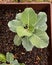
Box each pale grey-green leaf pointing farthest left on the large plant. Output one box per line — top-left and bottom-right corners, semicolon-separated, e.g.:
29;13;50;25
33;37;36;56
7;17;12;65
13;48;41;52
8;20;22;32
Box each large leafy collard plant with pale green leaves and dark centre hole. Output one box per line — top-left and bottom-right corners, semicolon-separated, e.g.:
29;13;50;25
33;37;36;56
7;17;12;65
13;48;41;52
8;8;49;51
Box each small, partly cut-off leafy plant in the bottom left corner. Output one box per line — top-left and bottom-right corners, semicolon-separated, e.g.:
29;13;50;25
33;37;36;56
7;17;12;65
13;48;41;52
0;52;25;65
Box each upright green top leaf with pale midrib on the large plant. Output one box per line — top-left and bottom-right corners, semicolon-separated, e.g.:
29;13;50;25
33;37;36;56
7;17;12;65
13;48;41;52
21;8;37;28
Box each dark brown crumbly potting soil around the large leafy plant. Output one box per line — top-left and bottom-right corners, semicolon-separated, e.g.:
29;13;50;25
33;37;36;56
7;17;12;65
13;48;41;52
0;9;49;65
